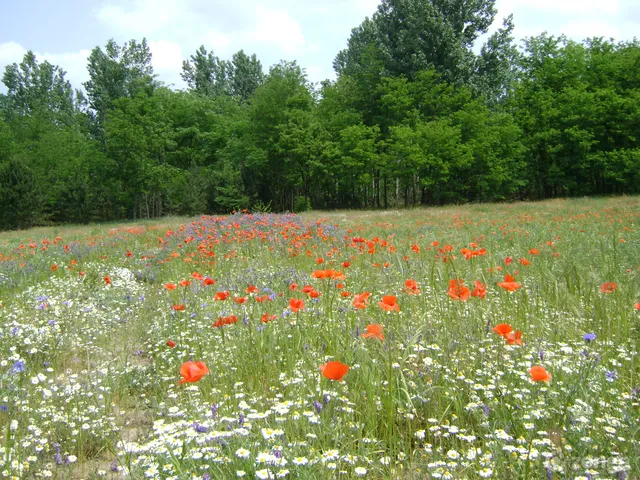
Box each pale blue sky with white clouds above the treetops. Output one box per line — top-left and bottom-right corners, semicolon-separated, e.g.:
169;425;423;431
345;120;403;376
0;0;640;91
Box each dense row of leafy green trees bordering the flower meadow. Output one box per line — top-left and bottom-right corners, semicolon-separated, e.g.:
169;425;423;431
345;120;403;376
0;0;640;229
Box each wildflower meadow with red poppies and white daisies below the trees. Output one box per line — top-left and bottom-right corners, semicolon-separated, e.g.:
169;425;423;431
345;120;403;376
0;197;640;480
